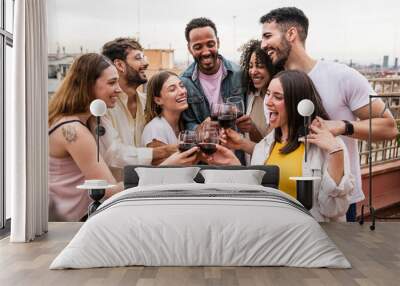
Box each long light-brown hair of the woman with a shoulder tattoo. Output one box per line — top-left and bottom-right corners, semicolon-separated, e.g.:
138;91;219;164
48;53;112;126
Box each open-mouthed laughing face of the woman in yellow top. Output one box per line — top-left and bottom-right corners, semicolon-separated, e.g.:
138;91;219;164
266;78;288;128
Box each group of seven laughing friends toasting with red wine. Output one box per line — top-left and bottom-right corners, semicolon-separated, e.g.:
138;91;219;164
48;7;398;221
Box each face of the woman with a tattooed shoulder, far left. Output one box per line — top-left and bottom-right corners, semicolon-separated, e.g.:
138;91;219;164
93;66;121;108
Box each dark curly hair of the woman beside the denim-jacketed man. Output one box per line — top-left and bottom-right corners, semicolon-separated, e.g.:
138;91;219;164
240;40;280;92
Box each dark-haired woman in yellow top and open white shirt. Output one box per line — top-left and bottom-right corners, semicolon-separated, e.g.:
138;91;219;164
203;71;354;221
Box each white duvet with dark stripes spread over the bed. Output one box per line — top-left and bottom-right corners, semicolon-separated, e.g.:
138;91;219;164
50;184;351;269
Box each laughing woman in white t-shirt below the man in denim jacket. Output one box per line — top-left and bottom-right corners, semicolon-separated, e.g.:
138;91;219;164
142;71;198;165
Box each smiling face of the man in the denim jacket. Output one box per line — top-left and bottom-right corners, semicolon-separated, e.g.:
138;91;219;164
188;26;219;74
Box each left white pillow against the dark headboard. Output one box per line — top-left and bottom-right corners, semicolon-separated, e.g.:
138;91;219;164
135;167;200;186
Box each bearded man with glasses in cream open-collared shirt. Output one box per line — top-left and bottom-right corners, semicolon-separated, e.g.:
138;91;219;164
100;38;177;180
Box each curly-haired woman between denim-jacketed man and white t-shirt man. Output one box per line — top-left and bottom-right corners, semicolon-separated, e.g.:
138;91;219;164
236;40;277;143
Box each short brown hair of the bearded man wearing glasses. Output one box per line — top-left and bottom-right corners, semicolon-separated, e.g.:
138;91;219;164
101;38;143;61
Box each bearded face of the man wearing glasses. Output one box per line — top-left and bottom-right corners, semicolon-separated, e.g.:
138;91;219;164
123;50;149;85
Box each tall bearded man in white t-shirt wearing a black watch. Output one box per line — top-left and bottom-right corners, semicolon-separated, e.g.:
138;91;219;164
260;7;398;221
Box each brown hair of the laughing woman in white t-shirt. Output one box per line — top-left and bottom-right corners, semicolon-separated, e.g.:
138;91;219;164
144;71;178;123
